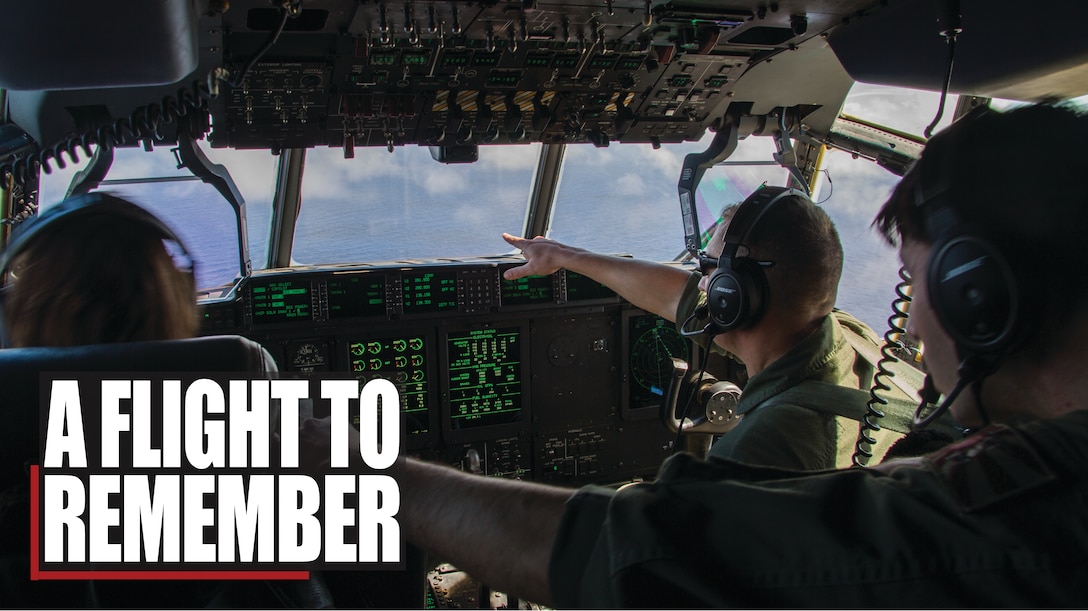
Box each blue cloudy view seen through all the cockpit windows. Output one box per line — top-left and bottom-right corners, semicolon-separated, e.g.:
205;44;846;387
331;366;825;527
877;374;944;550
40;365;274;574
41;85;979;332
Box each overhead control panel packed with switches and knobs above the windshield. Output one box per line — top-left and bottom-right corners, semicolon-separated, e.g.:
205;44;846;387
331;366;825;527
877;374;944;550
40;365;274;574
211;0;865;151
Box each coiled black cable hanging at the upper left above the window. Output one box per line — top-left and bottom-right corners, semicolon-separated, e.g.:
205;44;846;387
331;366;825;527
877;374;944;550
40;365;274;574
0;80;211;186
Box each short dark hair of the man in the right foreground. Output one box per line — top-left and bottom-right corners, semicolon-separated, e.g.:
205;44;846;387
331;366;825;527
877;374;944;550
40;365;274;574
873;104;1088;345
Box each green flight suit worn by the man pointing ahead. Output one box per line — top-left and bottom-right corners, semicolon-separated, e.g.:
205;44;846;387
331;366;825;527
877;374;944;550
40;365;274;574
676;273;878;471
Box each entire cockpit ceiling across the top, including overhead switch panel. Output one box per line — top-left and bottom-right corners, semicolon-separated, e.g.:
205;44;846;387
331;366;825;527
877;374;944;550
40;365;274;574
0;0;1088;156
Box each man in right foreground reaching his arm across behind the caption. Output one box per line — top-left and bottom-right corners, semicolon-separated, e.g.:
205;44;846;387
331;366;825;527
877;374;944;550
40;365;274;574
302;101;1088;608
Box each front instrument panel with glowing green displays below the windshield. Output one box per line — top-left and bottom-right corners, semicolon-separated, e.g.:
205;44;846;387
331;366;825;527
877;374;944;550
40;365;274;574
201;262;690;485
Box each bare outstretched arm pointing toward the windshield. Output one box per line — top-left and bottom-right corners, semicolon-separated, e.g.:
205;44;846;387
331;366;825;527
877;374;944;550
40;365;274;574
503;234;691;321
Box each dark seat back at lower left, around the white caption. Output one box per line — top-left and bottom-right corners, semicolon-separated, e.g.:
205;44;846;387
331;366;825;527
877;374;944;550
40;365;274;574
0;335;306;609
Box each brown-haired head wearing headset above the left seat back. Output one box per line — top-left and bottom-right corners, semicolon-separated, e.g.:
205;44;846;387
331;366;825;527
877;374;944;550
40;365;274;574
0;194;197;347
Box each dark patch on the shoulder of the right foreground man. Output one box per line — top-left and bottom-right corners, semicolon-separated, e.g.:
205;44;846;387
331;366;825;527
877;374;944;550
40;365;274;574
928;426;1056;512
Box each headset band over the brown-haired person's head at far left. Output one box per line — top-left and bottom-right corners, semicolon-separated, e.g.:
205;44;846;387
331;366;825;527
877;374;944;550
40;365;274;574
0;194;196;347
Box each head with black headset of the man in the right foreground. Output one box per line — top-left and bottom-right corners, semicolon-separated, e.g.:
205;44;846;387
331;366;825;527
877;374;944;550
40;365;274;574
874;105;1088;426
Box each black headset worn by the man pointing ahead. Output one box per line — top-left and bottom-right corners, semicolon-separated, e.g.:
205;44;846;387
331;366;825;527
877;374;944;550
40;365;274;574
698;187;812;333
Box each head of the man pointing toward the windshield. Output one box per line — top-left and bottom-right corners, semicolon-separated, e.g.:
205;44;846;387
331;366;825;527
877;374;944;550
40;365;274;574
700;187;842;331
